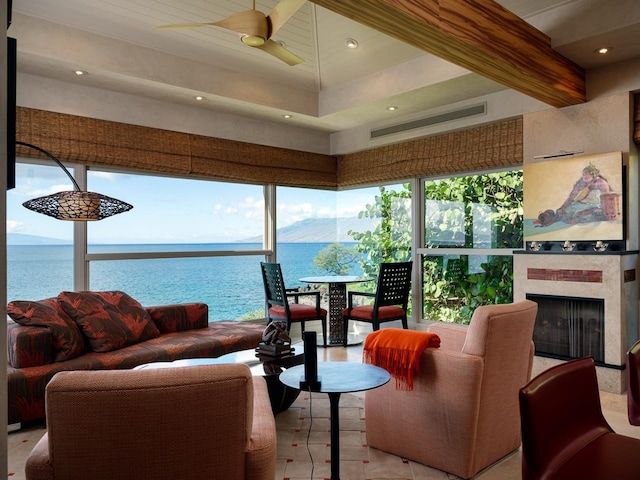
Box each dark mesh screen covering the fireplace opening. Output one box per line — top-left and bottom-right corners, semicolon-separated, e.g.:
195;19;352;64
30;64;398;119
527;295;604;362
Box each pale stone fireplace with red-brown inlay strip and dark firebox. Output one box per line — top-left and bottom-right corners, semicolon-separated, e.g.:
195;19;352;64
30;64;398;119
513;250;639;394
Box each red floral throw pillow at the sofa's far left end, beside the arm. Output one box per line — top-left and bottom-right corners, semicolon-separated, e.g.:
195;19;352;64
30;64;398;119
7;298;85;362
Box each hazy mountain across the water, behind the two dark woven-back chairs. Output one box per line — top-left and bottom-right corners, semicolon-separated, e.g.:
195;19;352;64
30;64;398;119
241;217;374;243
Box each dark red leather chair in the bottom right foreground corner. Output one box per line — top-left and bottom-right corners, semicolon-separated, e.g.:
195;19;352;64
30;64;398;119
520;357;640;480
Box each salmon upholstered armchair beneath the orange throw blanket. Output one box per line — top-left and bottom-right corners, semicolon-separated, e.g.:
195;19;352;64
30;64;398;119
365;300;538;478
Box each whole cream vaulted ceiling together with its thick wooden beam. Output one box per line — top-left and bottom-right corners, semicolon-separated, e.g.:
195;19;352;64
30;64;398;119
9;0;640;132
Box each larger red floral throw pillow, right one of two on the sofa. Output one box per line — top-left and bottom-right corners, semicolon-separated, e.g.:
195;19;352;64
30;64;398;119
58;291;160;352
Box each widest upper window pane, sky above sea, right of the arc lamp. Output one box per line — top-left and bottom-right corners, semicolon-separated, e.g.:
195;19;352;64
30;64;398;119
87;170;264;249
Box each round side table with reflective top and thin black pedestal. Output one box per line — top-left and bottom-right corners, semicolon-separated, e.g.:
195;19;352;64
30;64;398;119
280;362;391;480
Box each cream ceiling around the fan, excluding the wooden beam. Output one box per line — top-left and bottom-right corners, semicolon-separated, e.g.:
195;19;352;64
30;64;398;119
9;0;640;132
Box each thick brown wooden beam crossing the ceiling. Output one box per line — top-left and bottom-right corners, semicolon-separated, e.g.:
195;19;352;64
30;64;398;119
311;0;586;108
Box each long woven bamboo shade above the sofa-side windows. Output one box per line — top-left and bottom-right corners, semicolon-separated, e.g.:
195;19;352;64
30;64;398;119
16;107;336;189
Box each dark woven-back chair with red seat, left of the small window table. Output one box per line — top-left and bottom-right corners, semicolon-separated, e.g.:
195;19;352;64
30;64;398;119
260;262;327;346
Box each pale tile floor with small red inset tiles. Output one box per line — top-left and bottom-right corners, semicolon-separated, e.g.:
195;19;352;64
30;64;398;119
8;346;640;480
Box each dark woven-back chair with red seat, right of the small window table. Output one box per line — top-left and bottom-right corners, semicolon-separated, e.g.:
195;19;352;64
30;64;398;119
342;262;412;346
